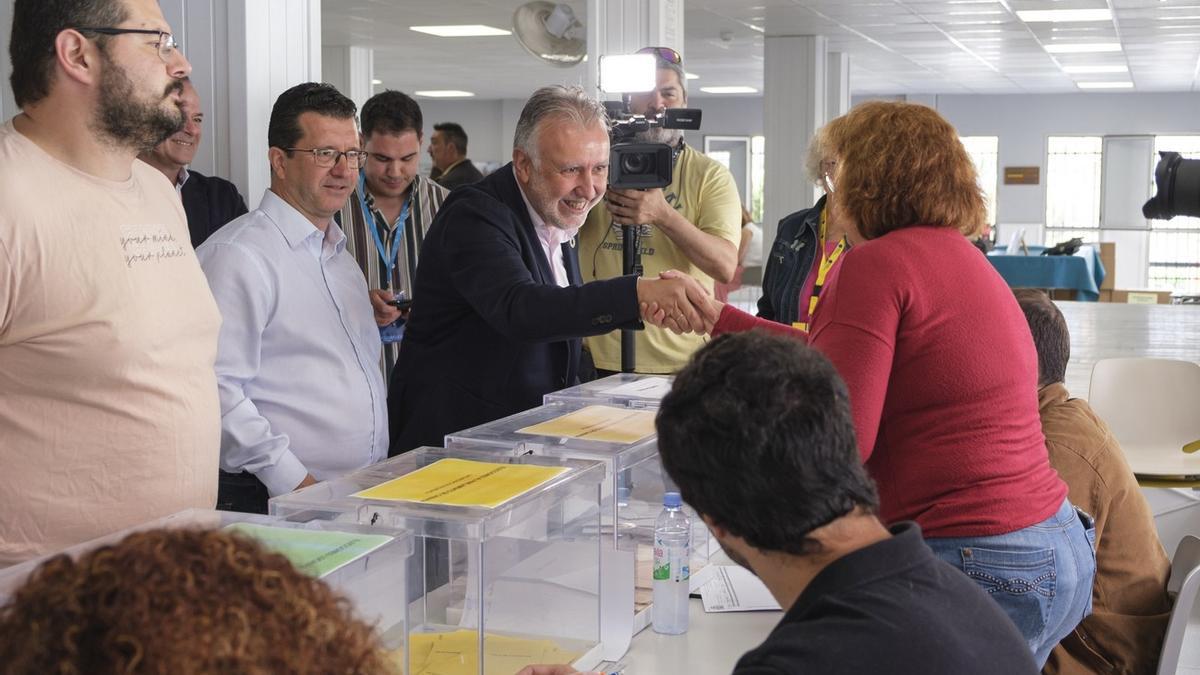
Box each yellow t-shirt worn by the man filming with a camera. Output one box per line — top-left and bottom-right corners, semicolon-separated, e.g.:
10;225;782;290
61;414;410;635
578;145;742;372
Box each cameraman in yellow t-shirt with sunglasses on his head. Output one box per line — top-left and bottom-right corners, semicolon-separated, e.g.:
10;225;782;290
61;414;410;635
580;47;742;376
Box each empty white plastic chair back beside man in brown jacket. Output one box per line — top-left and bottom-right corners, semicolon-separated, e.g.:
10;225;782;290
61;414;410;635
1087;358;1200;484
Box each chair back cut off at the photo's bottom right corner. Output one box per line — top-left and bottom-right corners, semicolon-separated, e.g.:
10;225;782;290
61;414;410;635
1158;534;1200;675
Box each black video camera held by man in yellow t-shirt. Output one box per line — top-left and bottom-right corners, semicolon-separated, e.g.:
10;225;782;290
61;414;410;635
605;101;701;190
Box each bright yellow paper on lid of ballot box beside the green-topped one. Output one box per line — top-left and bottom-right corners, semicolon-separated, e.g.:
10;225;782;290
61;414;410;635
354;459;566;508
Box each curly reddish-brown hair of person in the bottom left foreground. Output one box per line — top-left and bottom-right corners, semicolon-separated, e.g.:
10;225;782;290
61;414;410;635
0;530;396;675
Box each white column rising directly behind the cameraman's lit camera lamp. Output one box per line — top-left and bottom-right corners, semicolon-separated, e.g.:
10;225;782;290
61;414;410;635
582;0;688;98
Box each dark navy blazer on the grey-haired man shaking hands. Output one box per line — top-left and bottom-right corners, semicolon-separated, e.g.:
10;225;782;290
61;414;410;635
388;163;638;455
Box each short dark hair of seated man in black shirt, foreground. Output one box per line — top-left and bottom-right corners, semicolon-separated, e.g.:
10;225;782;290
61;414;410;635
655;330;878;555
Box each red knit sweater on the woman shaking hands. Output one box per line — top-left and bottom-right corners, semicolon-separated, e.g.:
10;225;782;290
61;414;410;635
713;227;1067;537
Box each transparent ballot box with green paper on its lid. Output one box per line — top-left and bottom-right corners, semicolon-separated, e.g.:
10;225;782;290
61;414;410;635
0;509;413;652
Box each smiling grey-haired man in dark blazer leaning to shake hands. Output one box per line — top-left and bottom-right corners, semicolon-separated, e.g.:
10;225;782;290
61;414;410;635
388;86;702;455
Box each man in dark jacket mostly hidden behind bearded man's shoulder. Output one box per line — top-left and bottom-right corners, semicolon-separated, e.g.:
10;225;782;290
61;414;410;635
138;78;247;249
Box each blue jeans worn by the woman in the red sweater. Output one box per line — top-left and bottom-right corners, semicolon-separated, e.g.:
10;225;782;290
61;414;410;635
925;500;1096;667
